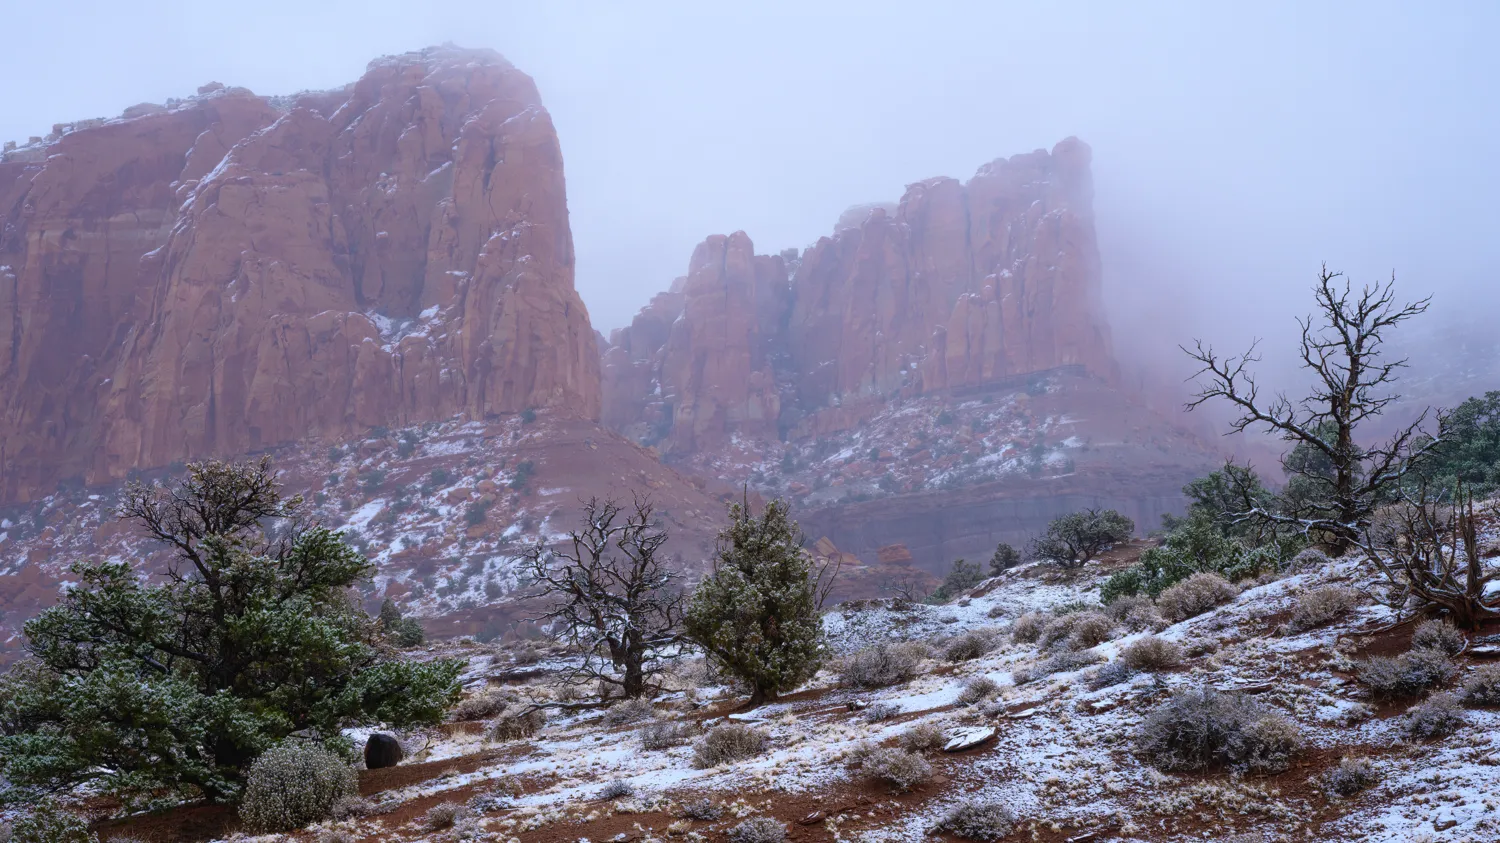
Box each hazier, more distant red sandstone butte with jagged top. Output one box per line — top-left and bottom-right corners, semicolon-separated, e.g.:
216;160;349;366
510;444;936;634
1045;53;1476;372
603;138;1119;456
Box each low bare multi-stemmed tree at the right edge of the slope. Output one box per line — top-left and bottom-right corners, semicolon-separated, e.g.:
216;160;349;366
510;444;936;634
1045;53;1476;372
1361;482;1500;629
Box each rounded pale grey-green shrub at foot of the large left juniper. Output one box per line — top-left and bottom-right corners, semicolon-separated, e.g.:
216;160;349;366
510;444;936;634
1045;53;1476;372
240;744;359;831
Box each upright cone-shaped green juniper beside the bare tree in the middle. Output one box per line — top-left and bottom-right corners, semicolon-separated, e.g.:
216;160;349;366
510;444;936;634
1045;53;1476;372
686;501;839;707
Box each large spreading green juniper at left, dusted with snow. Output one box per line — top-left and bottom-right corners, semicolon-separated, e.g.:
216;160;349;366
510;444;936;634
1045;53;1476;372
0;459;462;801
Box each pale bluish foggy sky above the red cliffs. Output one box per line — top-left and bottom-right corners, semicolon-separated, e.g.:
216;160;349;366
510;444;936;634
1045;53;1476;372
0;0;1500;405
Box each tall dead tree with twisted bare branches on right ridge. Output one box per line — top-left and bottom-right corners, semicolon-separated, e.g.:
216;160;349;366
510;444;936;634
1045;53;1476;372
1184;266;1443;554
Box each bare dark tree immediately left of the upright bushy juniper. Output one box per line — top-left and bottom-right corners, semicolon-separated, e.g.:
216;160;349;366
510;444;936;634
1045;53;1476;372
524;495;684;698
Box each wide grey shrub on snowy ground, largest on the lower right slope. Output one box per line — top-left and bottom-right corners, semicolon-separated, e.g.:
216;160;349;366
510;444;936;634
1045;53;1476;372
1136;687;1302;773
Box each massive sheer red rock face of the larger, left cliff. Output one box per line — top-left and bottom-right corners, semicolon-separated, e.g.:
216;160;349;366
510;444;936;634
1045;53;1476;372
0;48;600;500
